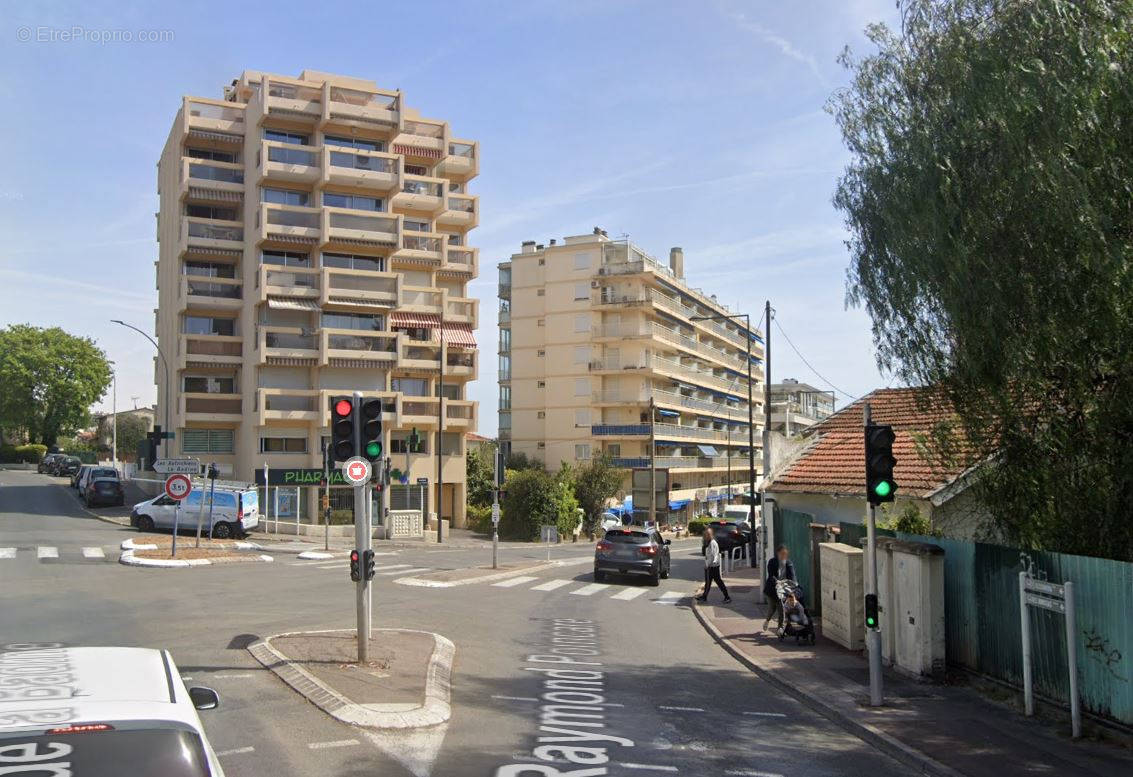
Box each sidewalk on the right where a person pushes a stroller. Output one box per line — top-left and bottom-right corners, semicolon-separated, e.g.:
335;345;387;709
693;567;1133;777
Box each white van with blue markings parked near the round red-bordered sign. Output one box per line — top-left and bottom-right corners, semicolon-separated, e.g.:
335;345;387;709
130;486;259;539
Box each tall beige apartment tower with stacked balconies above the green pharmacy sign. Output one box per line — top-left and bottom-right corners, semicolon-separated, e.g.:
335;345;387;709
155;70;478;526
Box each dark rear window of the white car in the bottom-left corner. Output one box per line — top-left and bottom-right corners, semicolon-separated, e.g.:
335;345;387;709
0;728;212;777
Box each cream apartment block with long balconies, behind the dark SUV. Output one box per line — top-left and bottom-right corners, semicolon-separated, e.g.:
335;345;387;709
499;229;764;520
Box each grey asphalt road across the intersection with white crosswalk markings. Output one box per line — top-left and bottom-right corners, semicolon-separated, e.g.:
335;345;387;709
0;471;908;777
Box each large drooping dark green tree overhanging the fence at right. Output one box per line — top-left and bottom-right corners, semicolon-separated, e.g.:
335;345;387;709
829;0;1133;560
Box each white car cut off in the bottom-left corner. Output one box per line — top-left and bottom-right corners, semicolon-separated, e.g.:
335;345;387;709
0;648;224;777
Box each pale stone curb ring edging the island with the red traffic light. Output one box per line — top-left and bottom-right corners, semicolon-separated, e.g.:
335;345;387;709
248;629;457;729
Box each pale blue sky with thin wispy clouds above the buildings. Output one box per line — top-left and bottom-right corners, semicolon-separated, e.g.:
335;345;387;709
0;0;896;436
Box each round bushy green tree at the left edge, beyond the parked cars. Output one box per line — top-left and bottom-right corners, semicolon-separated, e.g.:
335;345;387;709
0;324;110;446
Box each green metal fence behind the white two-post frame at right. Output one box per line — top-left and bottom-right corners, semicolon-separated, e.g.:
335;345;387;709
838;523;1133;725
